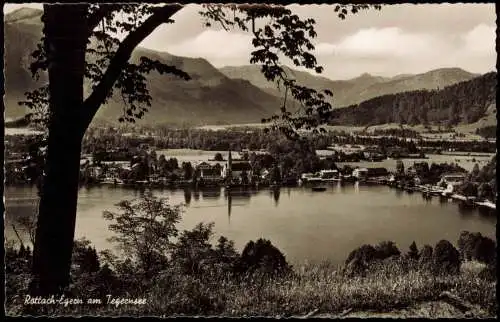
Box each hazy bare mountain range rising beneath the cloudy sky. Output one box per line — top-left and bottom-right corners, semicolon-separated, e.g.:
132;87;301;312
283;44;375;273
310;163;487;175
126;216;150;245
4;8;494;125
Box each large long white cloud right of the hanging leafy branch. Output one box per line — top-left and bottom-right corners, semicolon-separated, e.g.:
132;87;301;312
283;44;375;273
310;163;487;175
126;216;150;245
315;23;496;79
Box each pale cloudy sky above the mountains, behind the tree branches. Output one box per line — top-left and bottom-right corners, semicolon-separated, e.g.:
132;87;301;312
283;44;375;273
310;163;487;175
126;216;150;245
4;3;497;79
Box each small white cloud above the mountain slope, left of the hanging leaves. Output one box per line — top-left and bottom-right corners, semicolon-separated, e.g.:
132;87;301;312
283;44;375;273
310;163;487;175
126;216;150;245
166;30;253;66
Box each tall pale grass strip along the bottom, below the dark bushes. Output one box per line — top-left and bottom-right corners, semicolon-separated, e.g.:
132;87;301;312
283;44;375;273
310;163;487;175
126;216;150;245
7;244;496;316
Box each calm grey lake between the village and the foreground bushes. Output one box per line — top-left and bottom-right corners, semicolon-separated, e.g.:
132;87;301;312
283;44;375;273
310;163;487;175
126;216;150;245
5;184;496;264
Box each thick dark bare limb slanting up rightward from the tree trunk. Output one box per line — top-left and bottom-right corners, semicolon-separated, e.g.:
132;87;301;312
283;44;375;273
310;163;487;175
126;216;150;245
82;4;183;128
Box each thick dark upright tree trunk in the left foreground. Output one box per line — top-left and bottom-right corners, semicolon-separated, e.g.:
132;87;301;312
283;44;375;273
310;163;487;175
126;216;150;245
32;4;87;295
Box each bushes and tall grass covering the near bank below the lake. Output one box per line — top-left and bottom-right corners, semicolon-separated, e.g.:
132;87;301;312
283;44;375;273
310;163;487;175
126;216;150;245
6;196;496;316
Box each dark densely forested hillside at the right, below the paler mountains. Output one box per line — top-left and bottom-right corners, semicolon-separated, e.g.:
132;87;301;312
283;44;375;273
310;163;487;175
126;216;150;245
330;72;497;126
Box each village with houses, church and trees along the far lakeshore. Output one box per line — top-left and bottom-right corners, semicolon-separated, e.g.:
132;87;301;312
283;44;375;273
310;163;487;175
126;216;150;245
6;126;496;214
